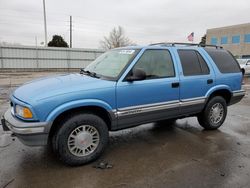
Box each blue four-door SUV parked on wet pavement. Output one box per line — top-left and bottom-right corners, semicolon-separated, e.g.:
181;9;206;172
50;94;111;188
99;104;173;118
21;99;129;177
1;43;245;165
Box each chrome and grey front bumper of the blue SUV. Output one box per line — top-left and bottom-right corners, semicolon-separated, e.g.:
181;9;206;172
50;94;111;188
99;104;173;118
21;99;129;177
1;109;51;146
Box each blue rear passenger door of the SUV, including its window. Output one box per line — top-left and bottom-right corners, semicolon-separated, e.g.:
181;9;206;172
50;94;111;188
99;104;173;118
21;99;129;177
177;49;215;115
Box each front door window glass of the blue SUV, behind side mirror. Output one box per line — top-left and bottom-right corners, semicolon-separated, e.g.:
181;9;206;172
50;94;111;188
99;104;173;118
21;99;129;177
133;50;175;79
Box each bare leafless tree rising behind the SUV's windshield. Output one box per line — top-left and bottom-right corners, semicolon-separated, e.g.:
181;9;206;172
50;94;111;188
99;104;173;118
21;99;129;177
100;26;134;50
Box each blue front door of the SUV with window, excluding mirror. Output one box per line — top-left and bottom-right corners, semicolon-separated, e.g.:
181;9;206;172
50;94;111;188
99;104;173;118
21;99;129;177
116;49;179;128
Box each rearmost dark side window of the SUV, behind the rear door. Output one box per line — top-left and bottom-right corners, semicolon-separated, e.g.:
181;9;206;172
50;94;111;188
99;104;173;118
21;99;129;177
204;48;241;73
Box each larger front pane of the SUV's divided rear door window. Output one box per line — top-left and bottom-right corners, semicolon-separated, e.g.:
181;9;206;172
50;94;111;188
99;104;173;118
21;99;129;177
178;50;202;76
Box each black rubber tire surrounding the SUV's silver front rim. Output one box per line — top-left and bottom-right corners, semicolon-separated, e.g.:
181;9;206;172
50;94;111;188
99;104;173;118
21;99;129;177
52;113;109;166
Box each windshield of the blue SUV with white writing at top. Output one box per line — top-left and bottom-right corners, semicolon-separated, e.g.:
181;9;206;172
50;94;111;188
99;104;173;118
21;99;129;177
84;49;139;79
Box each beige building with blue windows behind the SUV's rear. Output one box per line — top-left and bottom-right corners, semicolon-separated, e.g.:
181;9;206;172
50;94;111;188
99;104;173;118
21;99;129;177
206;23;250;58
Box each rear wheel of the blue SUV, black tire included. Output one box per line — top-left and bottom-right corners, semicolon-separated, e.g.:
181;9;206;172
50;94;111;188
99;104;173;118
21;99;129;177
197;96;227;130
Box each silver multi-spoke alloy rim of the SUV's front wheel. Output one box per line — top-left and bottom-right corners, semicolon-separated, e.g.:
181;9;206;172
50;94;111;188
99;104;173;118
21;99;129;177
68;125;100;157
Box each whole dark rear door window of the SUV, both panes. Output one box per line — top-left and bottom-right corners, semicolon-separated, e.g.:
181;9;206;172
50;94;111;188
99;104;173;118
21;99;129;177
178;50;209;76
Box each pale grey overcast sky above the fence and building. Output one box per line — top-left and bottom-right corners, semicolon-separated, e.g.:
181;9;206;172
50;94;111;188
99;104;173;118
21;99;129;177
0;0;250;48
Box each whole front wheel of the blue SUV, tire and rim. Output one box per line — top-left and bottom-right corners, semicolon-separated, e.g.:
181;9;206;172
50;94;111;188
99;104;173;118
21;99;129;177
52;114;109;165
